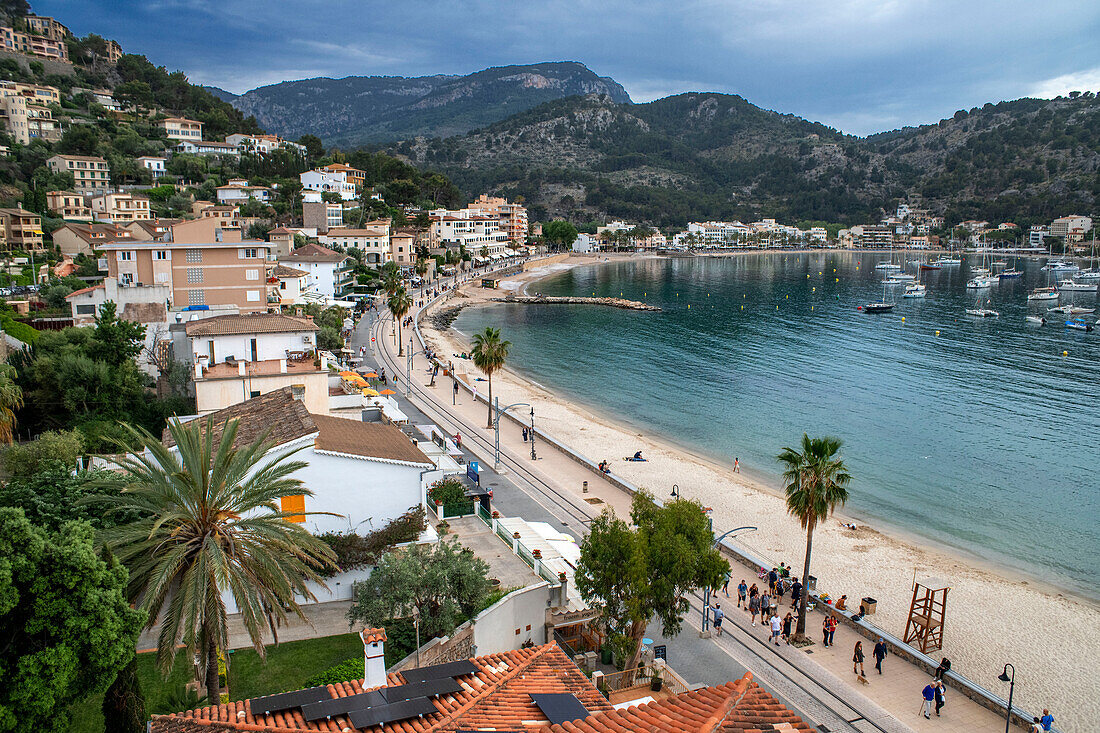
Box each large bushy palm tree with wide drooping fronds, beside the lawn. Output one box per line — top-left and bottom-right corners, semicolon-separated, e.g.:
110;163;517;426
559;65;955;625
94;417;336;700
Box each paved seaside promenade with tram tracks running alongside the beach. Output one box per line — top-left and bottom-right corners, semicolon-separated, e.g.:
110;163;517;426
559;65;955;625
352;277;1004;733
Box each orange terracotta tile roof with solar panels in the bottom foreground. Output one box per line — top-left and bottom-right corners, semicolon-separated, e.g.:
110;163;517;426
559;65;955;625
151;644;813;733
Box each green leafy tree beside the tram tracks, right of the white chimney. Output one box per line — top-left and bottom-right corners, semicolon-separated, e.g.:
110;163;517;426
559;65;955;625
576;491;729;668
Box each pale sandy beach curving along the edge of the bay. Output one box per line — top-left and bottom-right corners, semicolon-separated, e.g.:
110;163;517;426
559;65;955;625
421;256;1100;733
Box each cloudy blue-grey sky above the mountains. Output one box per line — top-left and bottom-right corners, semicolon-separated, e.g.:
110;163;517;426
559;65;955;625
31;0;1100;135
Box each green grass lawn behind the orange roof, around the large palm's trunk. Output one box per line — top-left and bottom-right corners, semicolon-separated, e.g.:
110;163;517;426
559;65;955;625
69;634;363;733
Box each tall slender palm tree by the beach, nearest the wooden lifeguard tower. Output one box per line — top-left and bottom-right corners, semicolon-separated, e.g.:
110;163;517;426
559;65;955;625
778;433;851;637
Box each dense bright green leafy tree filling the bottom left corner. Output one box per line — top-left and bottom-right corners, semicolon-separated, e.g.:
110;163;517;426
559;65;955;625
0;507;145;733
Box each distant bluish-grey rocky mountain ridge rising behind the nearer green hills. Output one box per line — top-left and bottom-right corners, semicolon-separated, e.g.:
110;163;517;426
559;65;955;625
208;62;630;147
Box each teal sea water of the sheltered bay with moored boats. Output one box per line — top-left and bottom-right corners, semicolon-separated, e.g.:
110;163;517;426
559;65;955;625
454;252;1100;597
